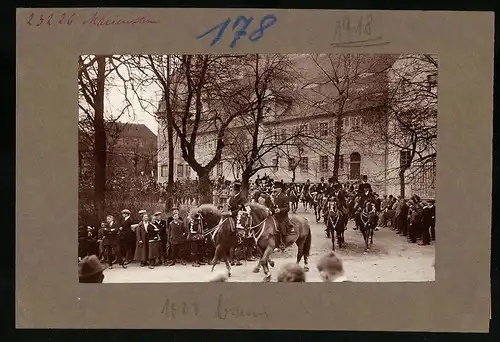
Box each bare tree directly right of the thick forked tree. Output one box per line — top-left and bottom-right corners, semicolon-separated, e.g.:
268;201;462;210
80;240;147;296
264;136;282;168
221;54;302;194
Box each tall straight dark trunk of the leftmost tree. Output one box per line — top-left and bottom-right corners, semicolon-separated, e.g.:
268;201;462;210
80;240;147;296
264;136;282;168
94;56;106;220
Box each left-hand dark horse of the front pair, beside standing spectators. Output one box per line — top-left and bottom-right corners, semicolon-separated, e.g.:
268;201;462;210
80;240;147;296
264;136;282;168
188;204;242;276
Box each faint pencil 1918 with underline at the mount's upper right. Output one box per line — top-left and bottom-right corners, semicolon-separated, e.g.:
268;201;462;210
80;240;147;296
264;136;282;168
330;14;389;48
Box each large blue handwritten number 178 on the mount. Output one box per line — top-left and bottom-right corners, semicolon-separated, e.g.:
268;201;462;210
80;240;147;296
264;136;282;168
196;14;277;48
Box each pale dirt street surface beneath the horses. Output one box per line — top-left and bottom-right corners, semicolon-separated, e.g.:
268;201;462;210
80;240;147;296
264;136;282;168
104;209;435;283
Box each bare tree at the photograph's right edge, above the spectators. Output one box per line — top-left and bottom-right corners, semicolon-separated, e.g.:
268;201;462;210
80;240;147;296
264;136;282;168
370;54;438;197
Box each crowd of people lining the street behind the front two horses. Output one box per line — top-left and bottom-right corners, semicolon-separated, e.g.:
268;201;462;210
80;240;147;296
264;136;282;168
78;171;435;278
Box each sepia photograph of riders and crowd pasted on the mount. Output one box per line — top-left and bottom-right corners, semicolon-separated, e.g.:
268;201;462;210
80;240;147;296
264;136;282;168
75;53;438;283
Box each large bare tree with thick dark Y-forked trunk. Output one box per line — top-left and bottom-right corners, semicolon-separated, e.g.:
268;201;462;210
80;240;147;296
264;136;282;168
141;55;250;203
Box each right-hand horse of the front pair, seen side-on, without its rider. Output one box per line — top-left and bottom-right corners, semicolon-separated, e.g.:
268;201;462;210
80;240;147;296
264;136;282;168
239;203;311;282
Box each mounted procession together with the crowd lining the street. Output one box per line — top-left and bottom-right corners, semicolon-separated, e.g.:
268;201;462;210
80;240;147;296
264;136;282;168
79;176;435;282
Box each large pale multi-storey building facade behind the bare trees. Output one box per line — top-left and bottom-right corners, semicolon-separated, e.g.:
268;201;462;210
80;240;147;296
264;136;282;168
158;55;438;195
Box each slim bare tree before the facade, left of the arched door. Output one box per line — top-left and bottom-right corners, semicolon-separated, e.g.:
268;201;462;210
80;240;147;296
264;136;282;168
294;54;392;177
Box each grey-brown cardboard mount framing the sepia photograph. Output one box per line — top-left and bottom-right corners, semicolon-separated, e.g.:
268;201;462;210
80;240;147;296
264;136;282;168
16;8;494;332
